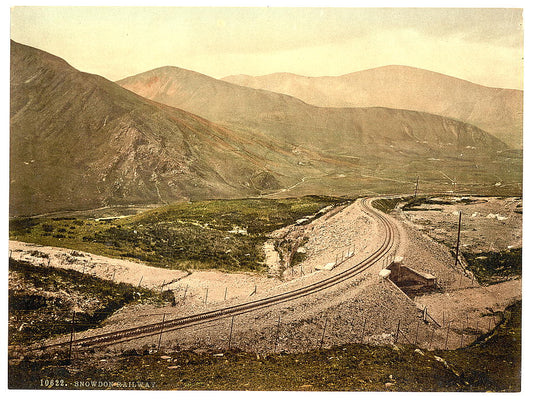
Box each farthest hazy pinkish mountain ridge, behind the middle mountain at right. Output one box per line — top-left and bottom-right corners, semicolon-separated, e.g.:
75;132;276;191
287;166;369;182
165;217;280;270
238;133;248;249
223;66;523;148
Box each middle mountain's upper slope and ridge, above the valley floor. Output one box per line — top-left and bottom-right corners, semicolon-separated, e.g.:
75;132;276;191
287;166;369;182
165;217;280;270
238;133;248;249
118;67;507;157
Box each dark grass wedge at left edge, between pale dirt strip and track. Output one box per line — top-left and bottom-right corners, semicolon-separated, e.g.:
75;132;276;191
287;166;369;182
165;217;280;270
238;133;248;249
8;259;174;345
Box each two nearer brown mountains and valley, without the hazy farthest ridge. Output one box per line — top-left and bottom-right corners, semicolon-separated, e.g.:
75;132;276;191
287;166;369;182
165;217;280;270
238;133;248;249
10;42;521;216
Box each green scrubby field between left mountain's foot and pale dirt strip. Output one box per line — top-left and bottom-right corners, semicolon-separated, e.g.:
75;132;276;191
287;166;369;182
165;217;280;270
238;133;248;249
10;196;345;272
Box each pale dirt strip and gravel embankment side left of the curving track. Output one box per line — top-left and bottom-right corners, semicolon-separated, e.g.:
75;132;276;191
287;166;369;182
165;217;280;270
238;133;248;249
9;203;378;309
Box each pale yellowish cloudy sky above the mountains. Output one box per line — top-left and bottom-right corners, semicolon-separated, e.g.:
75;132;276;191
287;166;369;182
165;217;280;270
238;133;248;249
11;7;523;89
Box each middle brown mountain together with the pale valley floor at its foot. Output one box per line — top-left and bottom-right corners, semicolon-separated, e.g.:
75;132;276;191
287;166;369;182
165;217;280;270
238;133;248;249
118;67;521;195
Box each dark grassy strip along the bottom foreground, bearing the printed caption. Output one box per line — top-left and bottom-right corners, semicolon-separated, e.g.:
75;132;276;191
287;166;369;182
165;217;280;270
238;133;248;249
9;303;522;392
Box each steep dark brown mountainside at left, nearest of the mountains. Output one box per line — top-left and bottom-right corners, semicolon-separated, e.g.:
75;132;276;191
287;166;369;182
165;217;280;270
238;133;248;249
10;42;296;215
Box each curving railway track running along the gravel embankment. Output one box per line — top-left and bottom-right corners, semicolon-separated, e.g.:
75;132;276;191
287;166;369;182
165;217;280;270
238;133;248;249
38;199;397;349
